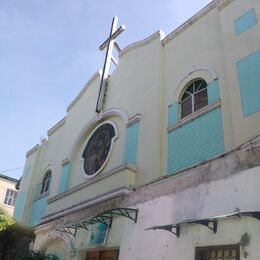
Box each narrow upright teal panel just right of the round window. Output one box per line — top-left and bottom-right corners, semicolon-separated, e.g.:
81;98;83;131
124;122;139;164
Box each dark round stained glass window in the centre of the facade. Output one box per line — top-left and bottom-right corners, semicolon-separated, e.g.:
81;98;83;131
82;123;116;177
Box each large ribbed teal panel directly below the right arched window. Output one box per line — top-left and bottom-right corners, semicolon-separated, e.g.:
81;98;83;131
167;108;224;174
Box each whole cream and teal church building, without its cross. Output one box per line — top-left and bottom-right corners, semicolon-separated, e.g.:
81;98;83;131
15;0;260;260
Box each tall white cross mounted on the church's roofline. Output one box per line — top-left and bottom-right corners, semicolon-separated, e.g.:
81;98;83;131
96;16;125;113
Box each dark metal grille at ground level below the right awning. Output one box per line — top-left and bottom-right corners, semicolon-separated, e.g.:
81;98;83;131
196;245;240;260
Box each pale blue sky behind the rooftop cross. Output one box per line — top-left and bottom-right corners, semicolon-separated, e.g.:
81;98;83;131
0;0;210;178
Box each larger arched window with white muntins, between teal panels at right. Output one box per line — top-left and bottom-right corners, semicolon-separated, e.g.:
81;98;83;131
181;79;208;118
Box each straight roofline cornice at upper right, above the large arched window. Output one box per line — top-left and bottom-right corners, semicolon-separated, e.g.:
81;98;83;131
162;0;234;46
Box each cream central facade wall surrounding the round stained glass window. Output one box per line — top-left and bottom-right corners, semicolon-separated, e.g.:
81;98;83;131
20;34;165;217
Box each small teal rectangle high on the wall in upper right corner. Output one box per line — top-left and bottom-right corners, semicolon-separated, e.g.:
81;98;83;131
235;8;257;36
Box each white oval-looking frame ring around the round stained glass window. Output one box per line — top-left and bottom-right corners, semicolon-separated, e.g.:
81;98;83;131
81;120;118;179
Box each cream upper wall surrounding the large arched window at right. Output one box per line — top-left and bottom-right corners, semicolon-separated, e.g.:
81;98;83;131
163;0;260;155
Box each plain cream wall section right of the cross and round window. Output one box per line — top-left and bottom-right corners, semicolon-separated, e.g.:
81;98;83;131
105;35;162;187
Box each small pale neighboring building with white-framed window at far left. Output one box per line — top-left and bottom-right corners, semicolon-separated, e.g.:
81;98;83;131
0;174;18;216
